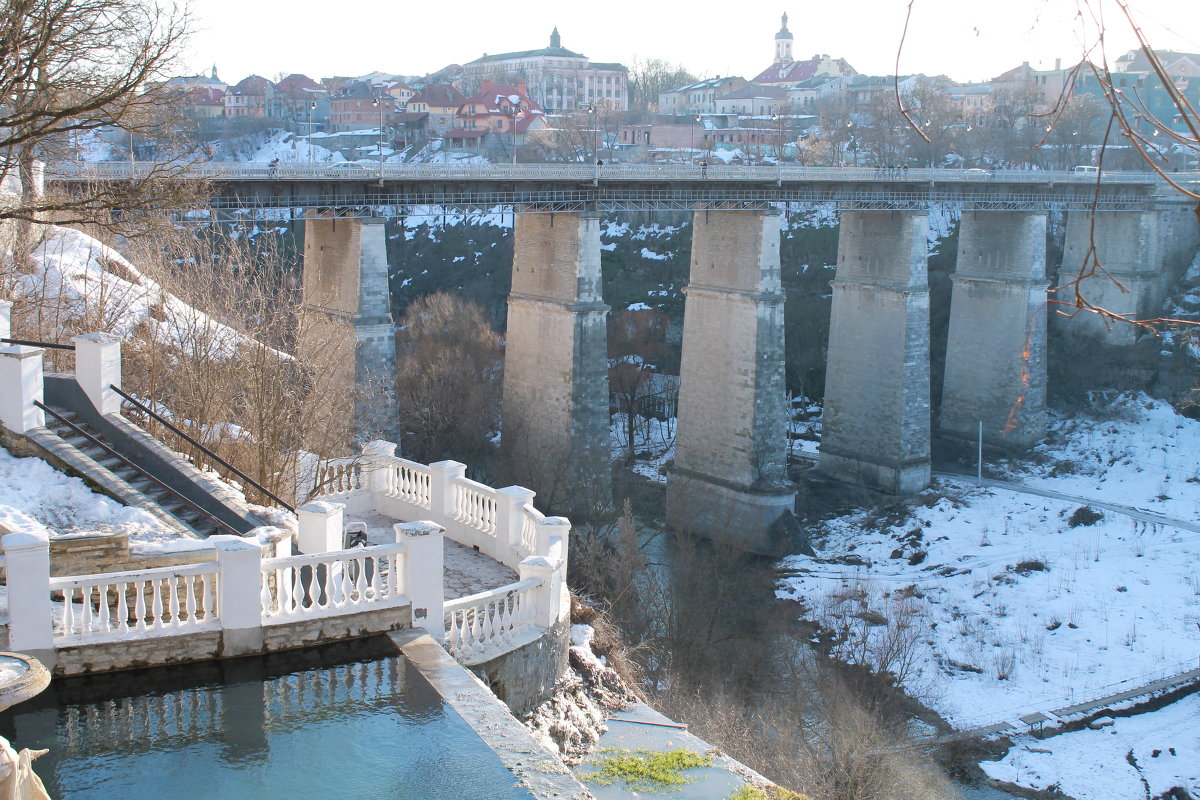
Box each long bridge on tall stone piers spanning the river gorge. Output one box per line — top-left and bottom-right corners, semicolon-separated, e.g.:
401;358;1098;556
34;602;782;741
47;163;1200;553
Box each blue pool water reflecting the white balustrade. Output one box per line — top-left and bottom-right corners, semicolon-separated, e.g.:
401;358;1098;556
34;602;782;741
0;651;529;800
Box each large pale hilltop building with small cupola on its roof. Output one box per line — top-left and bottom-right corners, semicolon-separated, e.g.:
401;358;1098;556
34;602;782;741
462;28;629;112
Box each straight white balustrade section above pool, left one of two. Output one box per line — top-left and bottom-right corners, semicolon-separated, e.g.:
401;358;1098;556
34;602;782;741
50;561;218;646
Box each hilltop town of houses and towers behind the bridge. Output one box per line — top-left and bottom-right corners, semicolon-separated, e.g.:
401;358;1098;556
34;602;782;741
145;13;1200;169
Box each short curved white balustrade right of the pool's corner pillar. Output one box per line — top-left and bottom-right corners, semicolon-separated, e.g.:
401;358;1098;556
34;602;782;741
444;578;542;657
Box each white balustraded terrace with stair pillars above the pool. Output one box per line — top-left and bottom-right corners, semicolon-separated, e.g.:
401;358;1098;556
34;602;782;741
0;316;570;708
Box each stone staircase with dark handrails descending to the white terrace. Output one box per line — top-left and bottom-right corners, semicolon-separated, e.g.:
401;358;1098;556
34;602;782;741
31;408;244;539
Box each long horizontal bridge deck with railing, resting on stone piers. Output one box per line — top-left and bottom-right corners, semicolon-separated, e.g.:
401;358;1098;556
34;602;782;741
47;162;1200;216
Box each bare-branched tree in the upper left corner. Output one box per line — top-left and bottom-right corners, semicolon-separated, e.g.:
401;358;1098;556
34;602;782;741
0;0;204;246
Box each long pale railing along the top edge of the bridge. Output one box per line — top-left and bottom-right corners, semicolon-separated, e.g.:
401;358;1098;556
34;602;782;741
47;161;1198;185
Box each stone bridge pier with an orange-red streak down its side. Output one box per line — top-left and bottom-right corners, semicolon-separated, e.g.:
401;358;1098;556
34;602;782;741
938;211;1048;449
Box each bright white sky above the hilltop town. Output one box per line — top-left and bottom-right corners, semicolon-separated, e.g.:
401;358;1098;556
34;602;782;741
184;0;1200;83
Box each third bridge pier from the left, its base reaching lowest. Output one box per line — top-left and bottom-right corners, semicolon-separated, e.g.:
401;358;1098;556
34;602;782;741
667;211;796;554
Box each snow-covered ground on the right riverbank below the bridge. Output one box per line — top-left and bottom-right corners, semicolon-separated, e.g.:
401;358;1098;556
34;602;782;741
779;395;1200;800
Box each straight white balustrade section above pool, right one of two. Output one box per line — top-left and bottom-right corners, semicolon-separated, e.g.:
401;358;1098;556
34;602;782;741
259;543;408;625
